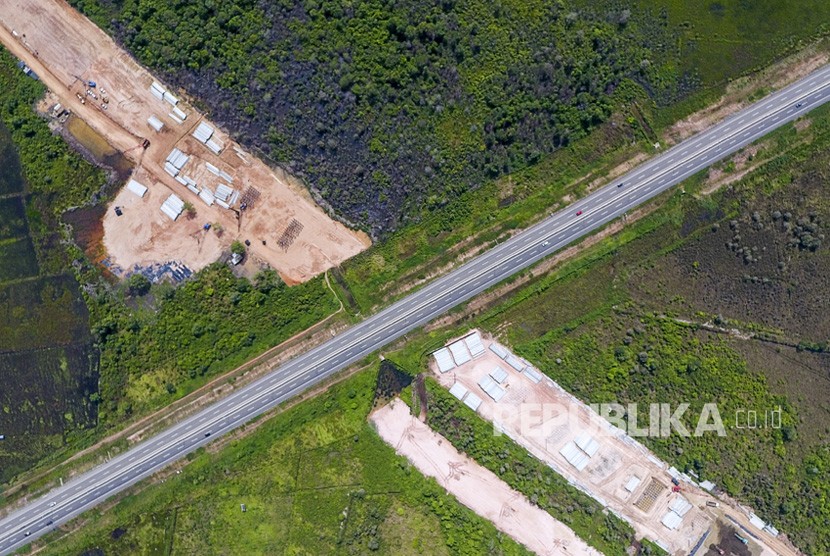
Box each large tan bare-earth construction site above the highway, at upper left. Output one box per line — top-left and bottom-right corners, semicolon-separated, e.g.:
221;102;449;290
0;0;370;283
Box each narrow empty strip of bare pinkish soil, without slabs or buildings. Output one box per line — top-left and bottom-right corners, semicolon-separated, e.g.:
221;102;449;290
371;399;600;555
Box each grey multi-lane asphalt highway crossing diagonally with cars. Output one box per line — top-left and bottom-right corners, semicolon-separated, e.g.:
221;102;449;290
0;66;830;554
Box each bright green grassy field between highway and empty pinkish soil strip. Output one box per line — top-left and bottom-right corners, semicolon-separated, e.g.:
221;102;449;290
39;371;527;555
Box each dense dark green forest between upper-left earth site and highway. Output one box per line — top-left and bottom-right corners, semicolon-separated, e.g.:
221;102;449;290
70;0;683;236
